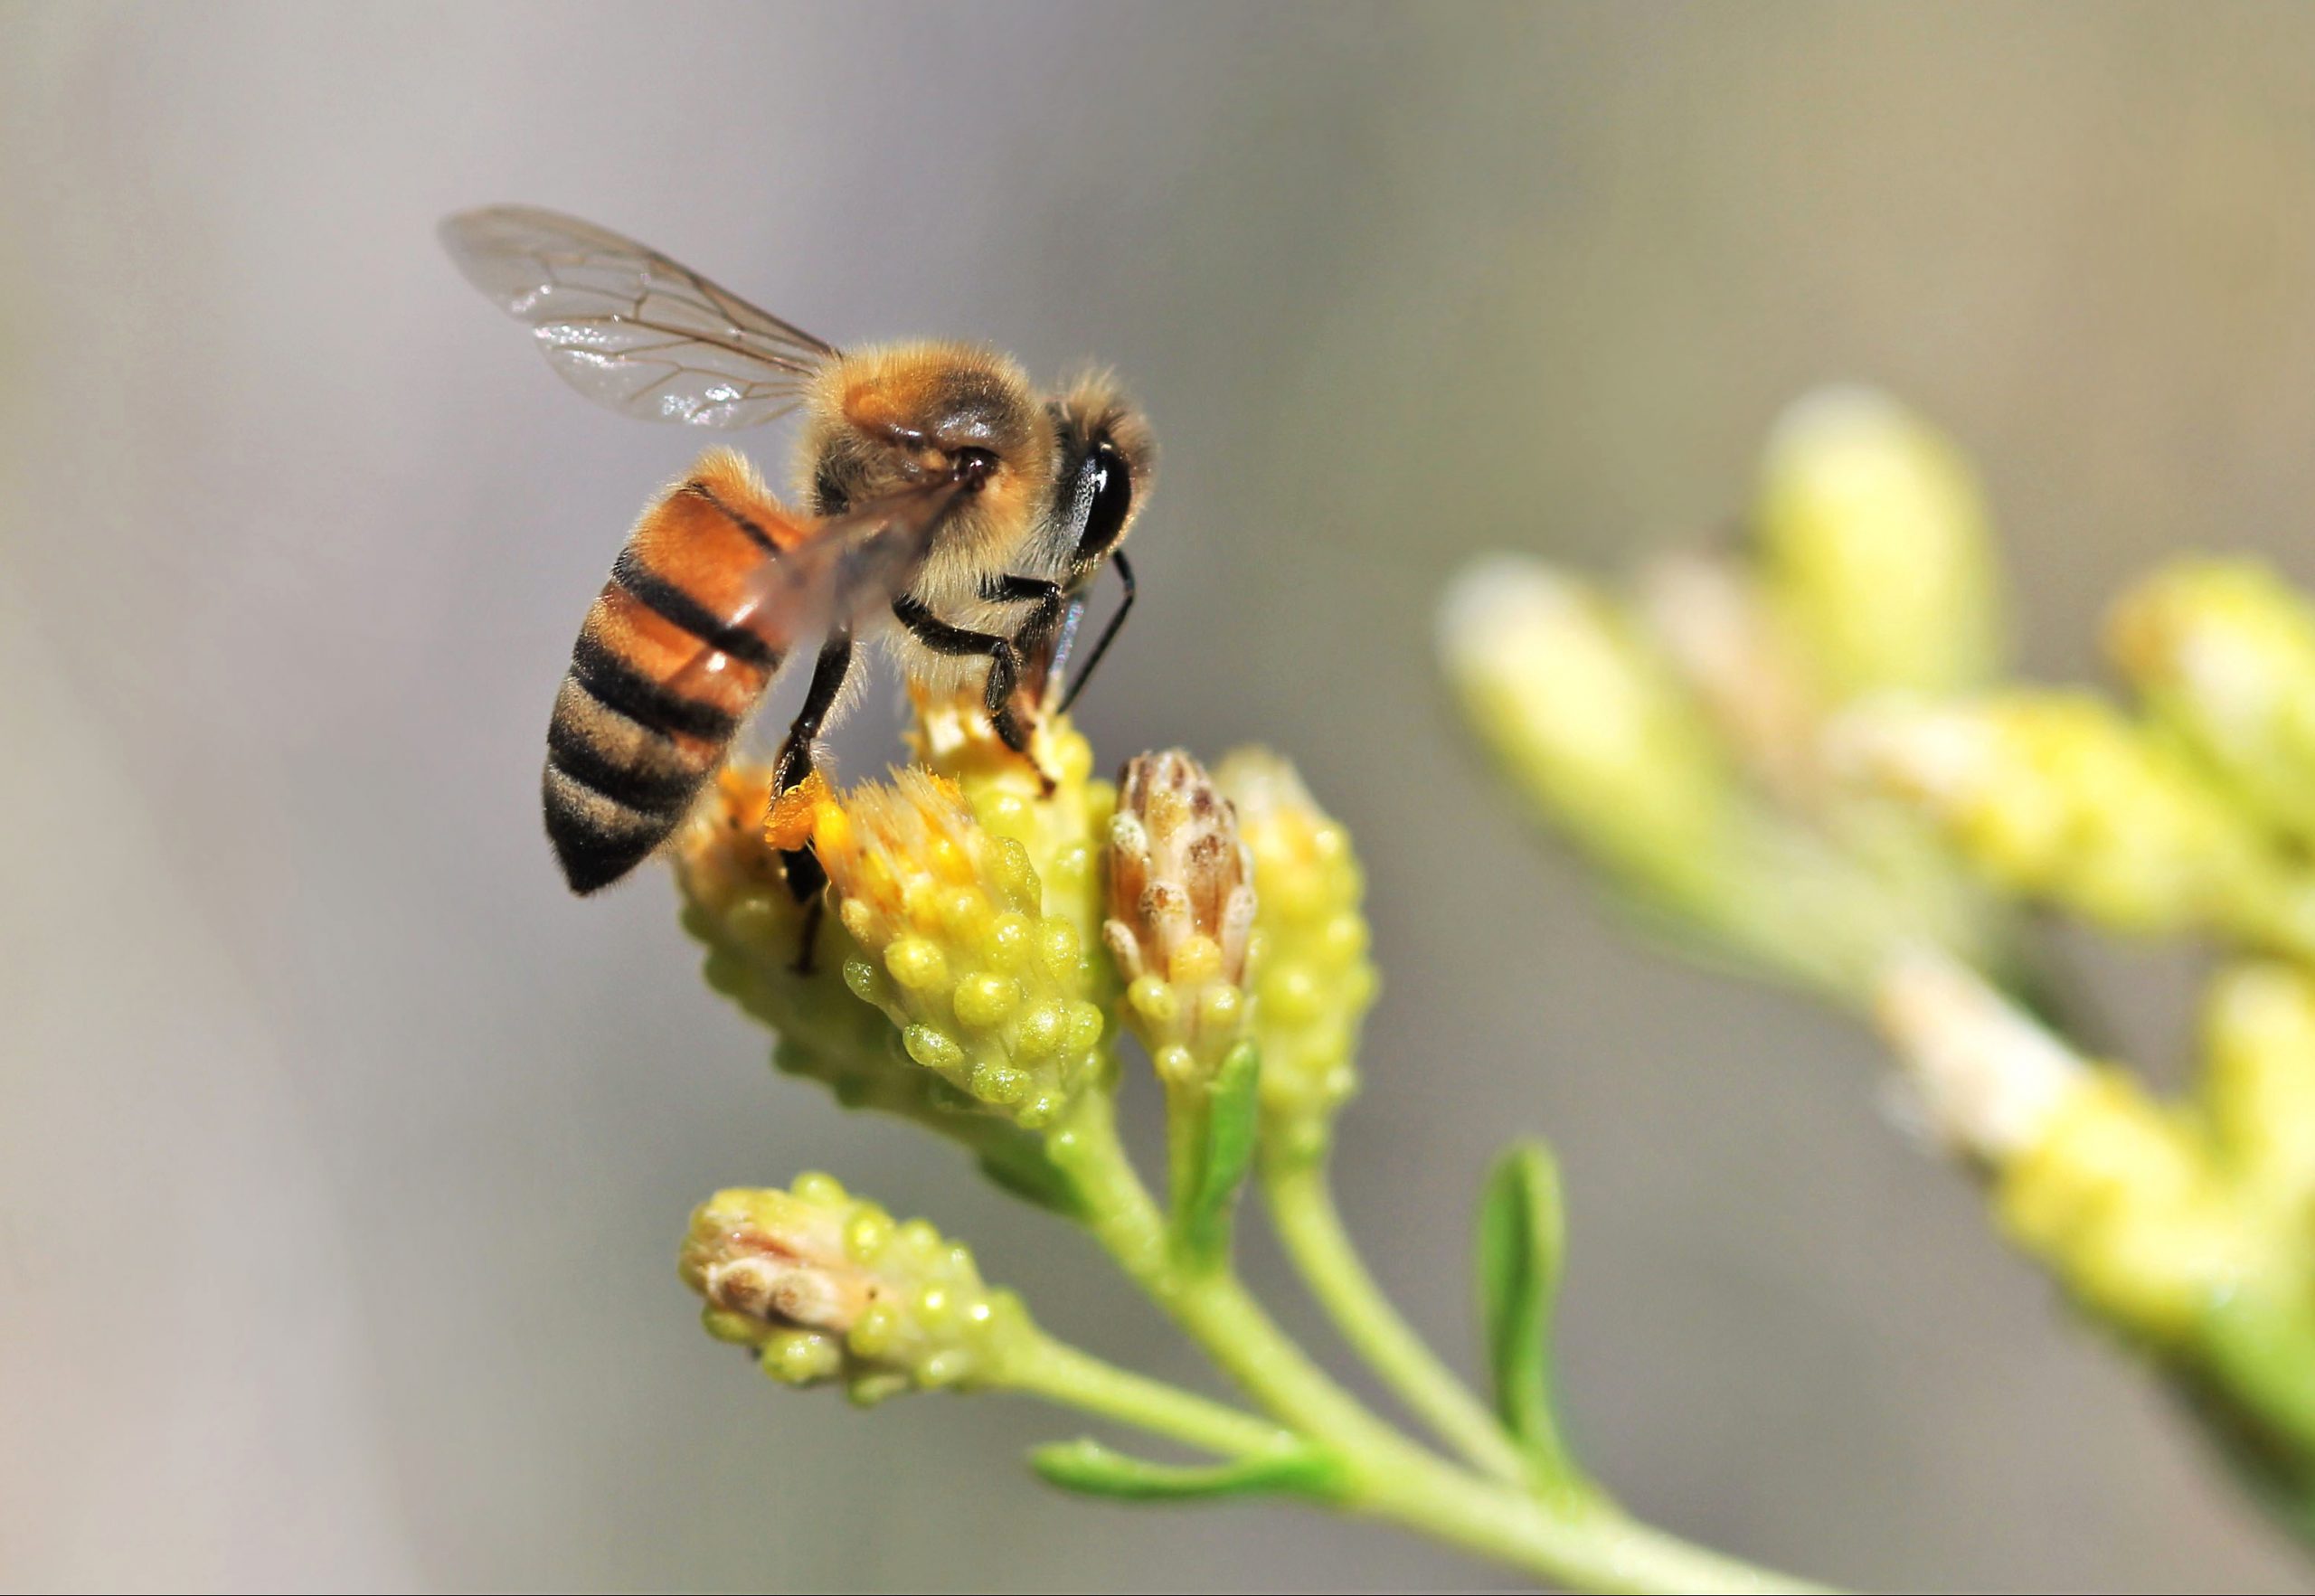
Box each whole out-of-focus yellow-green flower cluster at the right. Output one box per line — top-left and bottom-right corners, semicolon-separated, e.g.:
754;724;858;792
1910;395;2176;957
1444;392;2315;1522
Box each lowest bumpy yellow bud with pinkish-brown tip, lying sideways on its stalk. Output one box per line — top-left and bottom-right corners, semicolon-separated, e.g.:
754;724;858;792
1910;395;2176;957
678;1175;1035;1402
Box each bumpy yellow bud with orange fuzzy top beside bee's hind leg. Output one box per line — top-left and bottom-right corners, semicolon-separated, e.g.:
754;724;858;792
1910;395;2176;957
813;769;1102;1129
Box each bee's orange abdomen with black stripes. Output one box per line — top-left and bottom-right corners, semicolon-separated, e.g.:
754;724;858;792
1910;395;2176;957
544;449;798;892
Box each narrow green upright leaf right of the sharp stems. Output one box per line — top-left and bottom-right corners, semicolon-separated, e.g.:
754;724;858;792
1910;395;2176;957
1477;1142;1565;1467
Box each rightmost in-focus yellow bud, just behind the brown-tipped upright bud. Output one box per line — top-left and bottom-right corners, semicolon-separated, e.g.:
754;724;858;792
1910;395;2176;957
1213;748;1377;1158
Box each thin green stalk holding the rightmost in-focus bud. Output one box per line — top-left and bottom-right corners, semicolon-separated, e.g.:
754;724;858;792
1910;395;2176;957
1261;1158;1528;1485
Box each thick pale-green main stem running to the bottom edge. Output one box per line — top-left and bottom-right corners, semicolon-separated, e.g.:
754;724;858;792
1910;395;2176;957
1049;1093;1822;1591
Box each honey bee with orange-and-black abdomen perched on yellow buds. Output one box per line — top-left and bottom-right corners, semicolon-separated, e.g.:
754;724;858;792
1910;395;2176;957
442;206;1155;896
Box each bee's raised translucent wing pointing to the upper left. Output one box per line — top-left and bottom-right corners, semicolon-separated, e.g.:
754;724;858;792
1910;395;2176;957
442;206;836;426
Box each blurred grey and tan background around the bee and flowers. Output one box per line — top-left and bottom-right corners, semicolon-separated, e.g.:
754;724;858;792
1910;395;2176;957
0;5;2315;1589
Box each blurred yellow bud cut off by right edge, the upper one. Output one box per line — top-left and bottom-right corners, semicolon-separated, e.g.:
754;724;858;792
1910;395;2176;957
2107;561;2315;848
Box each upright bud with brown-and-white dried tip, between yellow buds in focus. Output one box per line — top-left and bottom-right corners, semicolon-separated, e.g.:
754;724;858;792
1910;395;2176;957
1102;751;1255;1084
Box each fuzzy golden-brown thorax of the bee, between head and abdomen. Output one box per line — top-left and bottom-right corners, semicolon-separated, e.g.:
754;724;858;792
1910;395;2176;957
803;343;1054;542
